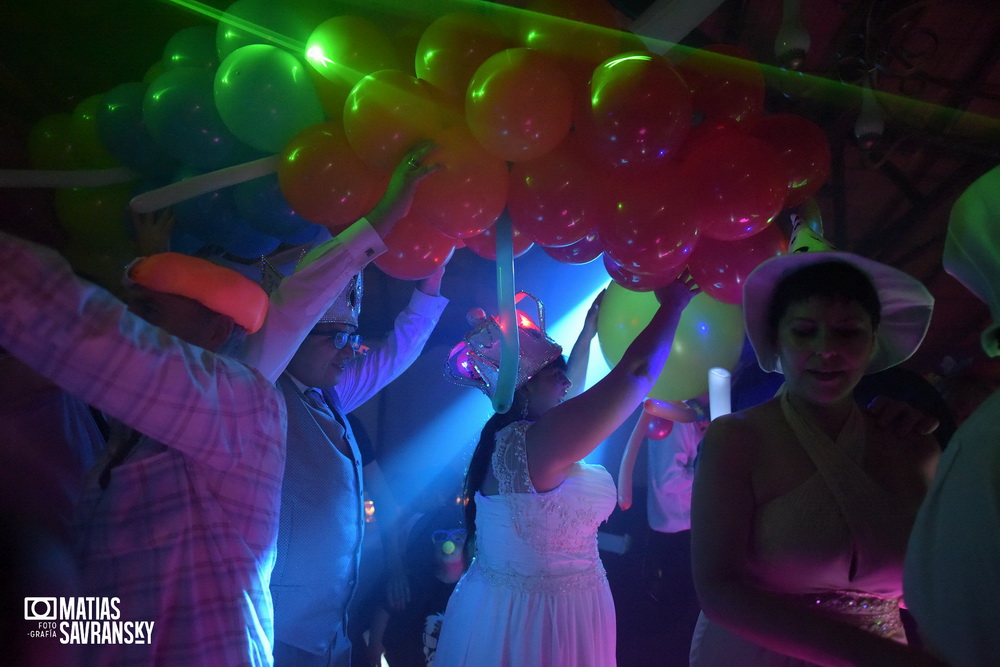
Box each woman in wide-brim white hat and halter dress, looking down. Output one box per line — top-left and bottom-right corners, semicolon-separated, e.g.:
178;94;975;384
691;228;940;666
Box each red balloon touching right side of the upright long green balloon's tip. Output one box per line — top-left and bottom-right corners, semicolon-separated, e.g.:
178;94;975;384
507;140;598;247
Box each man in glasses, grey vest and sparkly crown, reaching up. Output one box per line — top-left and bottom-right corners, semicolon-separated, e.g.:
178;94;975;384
271;266;448;667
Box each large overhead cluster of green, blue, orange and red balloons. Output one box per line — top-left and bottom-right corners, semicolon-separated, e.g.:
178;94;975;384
9;0;830;400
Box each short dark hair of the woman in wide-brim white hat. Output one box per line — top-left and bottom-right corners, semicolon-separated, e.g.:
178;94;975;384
767;259;882;340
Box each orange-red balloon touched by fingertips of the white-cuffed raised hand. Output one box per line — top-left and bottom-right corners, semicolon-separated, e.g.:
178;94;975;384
410;127;510;238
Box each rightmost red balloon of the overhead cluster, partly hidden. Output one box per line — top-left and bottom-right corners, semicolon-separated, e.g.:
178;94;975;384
749;113;830;208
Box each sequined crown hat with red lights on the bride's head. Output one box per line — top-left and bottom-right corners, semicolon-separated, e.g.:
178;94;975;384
445;292;562;398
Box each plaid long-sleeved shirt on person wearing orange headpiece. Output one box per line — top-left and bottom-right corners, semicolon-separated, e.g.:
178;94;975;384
0;234;285;667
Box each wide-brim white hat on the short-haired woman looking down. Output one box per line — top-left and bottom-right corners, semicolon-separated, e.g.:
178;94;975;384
743;250;934;373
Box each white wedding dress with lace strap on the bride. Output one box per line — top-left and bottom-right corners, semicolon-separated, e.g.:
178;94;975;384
434;422;616;667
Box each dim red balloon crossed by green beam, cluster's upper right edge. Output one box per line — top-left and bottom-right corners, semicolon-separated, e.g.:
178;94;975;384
677;44;764;124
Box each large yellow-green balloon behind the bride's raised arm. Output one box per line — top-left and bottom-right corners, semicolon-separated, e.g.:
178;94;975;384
597;283;745;401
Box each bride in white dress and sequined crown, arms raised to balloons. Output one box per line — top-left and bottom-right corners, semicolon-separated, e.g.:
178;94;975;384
434;278;697;667
